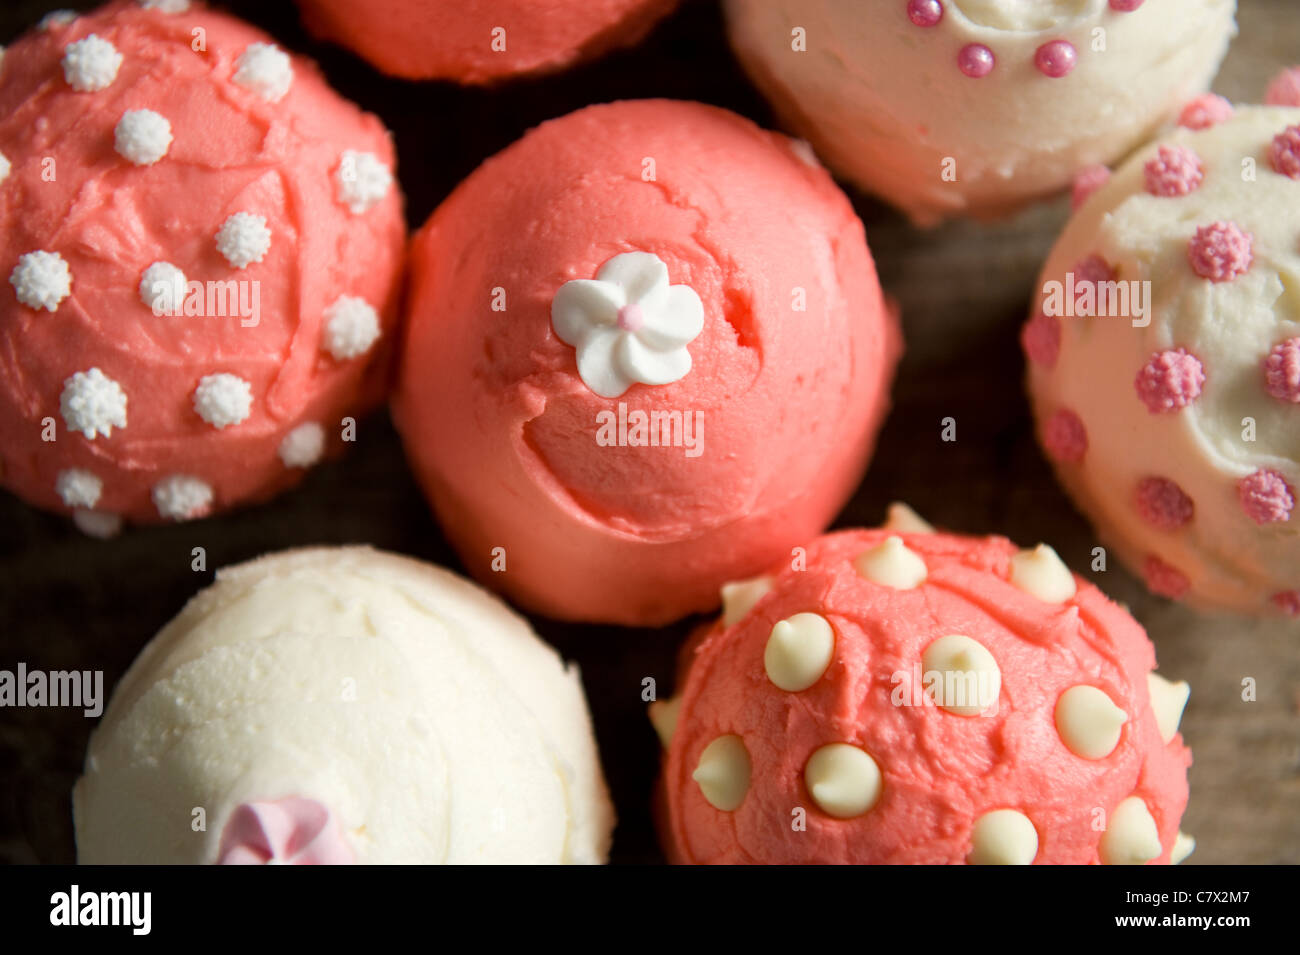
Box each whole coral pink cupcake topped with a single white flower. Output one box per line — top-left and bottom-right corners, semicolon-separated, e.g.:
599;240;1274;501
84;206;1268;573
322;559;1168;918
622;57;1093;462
393;100;900;625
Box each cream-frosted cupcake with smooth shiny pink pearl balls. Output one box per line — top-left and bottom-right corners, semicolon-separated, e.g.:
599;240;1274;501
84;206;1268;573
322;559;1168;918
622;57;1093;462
727;0;1236;225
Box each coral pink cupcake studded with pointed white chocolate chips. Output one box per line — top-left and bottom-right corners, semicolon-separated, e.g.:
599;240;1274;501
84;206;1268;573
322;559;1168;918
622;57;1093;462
651;521;1193;865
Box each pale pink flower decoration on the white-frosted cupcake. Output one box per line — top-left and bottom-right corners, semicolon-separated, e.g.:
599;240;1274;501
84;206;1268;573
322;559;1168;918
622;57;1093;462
217;796;355;865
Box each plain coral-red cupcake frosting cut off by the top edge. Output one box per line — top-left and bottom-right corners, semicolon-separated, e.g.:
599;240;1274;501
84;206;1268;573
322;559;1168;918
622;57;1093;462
298;0;677;83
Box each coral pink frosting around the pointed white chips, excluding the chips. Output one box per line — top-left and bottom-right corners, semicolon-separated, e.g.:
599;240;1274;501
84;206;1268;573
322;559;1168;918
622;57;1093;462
663;530;1191;864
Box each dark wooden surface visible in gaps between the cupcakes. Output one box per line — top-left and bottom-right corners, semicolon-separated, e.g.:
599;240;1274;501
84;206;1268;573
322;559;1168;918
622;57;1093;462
0;0;1300;863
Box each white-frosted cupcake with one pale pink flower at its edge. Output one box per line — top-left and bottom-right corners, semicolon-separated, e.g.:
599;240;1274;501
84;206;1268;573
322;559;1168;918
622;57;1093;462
73;547;614;864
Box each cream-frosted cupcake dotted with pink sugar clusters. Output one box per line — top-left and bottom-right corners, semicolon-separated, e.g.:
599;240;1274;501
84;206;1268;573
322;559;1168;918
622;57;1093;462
1022;95;1300;616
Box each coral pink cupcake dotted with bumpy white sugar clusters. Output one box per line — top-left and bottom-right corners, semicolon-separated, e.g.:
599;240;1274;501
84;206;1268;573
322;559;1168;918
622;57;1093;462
0;0;404;535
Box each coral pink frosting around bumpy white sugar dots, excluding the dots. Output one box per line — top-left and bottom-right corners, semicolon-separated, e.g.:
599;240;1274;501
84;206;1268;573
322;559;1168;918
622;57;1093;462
0;0;404;521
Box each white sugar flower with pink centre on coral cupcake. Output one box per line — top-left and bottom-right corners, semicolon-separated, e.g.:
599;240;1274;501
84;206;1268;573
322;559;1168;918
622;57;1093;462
551;252;705;398
